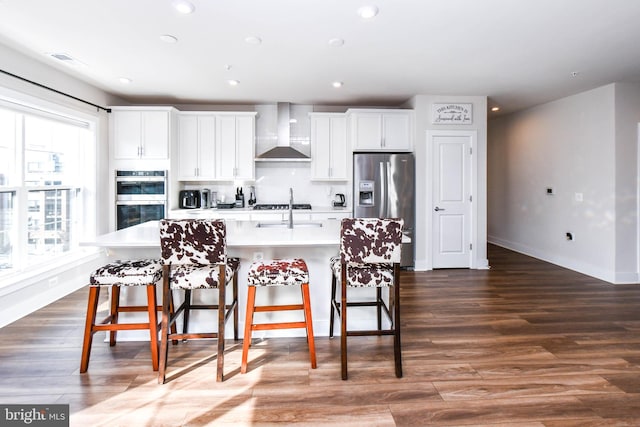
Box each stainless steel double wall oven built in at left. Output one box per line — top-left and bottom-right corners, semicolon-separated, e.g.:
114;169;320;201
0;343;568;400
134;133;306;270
116;170;167;230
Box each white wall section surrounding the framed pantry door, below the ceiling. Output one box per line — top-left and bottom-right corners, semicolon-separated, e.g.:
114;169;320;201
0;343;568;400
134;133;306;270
406;95;488;270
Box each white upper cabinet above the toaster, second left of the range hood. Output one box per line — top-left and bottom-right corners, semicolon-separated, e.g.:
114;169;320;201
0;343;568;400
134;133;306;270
177;112;216;181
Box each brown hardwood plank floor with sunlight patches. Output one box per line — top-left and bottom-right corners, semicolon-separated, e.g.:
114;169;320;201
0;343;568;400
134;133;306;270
0;246;640;427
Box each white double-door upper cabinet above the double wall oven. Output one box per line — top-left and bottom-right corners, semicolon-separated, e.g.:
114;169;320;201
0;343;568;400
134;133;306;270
111;107;174;160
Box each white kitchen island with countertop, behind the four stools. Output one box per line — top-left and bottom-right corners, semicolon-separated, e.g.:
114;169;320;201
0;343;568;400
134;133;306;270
82;219;375;340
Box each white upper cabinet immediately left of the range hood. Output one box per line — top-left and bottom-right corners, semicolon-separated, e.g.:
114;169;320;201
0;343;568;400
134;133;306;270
216;113;256;181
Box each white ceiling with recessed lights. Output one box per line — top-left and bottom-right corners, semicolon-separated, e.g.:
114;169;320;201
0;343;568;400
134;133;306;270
0;0;640;112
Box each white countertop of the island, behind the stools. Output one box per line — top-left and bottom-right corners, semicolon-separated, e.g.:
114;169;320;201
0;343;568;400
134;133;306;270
80;220;340;248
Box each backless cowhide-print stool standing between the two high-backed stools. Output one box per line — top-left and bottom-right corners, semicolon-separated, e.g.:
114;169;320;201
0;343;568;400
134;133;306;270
240;258;316;374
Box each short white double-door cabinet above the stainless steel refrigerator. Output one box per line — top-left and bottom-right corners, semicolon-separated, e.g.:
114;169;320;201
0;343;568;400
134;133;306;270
347;109;413;151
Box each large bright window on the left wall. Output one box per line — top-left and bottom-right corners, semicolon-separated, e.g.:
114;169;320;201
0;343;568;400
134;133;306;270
0;102;95;277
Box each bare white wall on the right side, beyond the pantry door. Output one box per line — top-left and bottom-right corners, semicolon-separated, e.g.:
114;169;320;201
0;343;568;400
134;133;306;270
488;84;640;283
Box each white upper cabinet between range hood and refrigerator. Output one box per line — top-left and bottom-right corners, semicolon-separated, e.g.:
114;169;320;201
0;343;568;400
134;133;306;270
309;113;350;181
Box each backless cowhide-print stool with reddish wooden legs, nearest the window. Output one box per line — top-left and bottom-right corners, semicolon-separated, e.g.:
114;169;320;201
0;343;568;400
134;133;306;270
80;259;162;372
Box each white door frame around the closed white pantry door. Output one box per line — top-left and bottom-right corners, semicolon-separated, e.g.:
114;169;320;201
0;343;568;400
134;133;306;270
425;129;479;270
